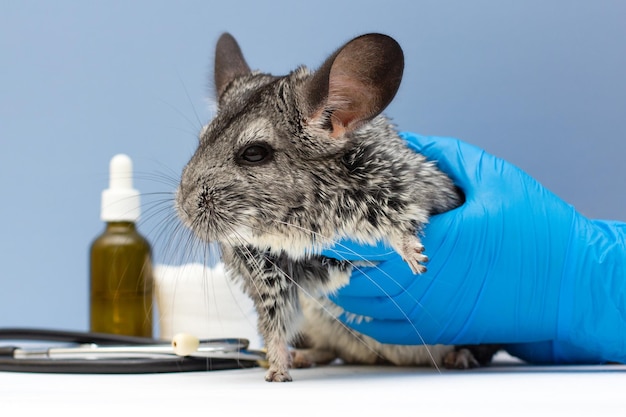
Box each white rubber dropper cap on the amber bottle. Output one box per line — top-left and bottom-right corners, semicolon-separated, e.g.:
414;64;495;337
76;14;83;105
100;154;141;222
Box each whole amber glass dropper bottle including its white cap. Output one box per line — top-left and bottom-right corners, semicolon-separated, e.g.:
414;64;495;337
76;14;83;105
90;154;153;337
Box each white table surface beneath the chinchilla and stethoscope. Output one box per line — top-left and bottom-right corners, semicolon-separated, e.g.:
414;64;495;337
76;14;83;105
0;352;626;417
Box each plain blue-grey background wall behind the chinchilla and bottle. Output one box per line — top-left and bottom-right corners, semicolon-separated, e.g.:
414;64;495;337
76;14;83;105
0;0;626;330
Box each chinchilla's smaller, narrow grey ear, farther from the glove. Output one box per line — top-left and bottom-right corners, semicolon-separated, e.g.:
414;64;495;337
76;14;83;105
214;33;250;101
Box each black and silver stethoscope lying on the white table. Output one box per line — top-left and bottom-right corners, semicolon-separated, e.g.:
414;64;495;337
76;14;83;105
0;328;265;374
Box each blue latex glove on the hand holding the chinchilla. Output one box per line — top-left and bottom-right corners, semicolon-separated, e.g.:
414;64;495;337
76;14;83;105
324;133;626;363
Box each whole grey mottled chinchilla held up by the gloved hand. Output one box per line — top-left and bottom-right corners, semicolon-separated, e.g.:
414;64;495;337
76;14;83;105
177;34;488;381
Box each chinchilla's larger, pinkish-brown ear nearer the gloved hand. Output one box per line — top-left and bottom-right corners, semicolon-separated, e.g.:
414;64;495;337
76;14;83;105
304;34;404;138
